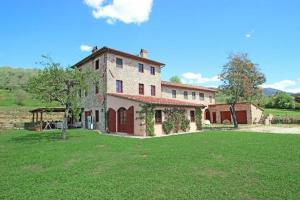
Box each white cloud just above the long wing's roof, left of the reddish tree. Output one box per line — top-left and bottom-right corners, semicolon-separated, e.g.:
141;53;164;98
182;72;220;84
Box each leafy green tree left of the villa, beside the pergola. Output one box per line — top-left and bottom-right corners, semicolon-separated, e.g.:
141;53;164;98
28;56;100;139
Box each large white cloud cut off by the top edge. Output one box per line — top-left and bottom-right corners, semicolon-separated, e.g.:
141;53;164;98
84;0;153;24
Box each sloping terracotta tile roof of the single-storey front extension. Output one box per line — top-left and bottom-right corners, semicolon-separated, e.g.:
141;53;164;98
107;93;205;107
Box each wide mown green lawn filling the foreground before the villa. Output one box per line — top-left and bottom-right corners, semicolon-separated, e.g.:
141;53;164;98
0;130;300;199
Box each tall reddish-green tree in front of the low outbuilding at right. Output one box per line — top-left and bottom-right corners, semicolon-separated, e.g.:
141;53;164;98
220;53;266;128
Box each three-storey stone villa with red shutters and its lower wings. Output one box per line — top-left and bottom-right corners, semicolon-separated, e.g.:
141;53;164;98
73;47;261;136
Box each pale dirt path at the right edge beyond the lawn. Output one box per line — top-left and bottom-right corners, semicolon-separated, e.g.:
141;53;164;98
238;125;300;134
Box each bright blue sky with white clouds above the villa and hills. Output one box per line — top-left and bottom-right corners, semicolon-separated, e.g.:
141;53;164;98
0;0;300;92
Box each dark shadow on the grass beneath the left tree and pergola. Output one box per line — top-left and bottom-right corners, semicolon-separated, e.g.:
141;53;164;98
10;131;80;143
